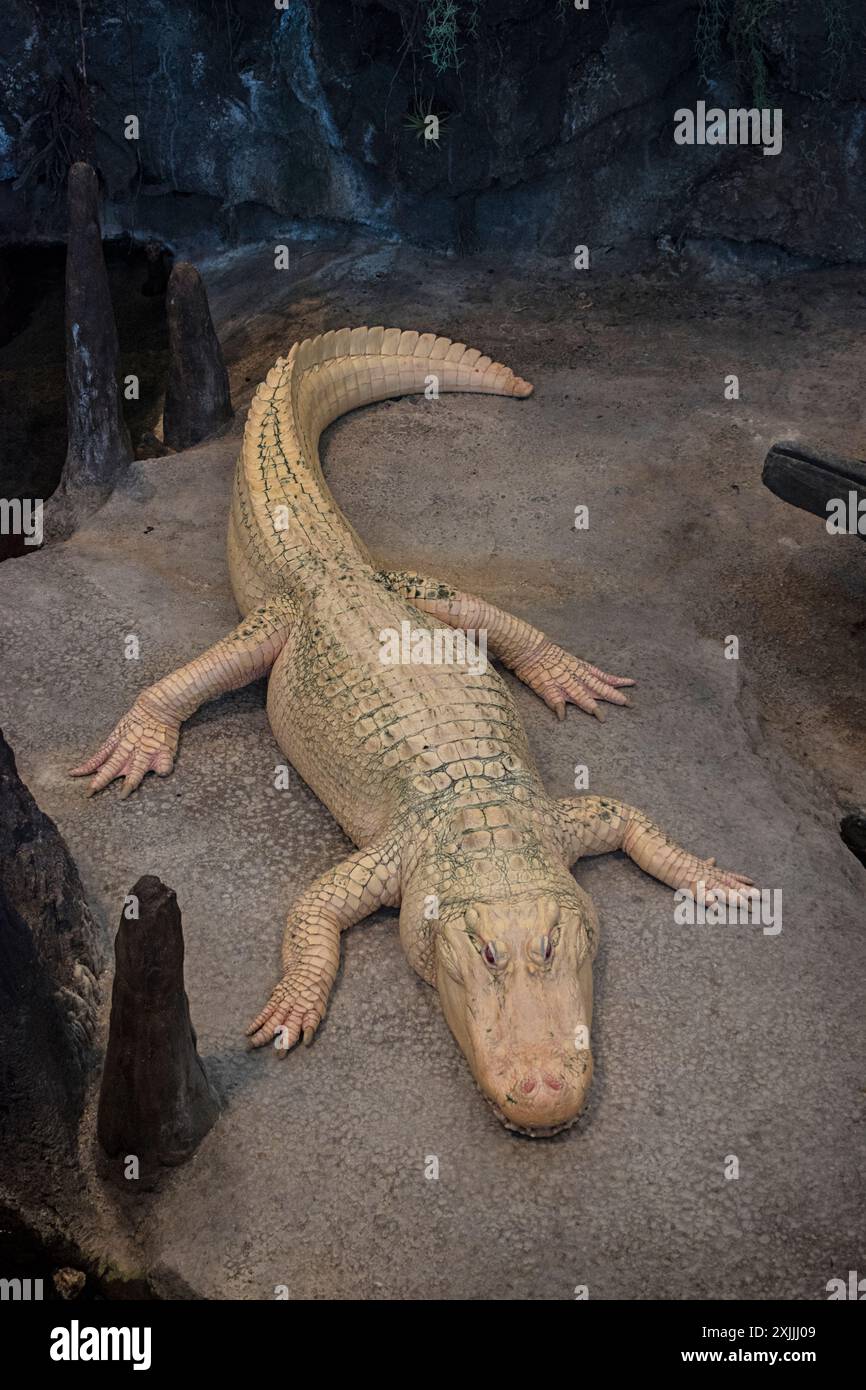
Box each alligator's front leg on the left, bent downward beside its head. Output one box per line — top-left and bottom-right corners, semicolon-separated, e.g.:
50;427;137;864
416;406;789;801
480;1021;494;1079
246;841;400;1056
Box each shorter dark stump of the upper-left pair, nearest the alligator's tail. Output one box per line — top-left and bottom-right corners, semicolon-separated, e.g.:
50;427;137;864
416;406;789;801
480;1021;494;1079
163;261;234;449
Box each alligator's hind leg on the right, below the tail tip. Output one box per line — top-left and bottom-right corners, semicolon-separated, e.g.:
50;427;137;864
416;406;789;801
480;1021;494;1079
378;570;634;720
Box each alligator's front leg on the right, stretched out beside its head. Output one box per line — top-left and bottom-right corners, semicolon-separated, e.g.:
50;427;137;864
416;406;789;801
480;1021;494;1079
556;796;753;894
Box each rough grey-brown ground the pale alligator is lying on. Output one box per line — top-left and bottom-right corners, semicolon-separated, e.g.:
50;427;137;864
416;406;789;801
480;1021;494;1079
0;233;866;1300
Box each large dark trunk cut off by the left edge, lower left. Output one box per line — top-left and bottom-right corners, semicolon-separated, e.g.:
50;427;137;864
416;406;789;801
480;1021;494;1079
0;734;103;1213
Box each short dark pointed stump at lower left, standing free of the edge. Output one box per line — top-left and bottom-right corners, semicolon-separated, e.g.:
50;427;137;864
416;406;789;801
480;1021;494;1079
97;876;220;1165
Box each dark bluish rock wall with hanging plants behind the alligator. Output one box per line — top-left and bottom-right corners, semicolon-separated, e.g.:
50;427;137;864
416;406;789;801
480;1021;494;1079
0;0;866;261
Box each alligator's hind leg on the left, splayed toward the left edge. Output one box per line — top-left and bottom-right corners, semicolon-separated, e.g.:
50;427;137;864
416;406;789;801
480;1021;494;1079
70;599;293;796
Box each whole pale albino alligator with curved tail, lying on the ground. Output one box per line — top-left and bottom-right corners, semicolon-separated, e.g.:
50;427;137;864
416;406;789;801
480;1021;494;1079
74;328;751;1134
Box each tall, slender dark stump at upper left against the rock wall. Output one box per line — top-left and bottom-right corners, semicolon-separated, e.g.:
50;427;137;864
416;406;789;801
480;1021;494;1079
46;164;132;539
